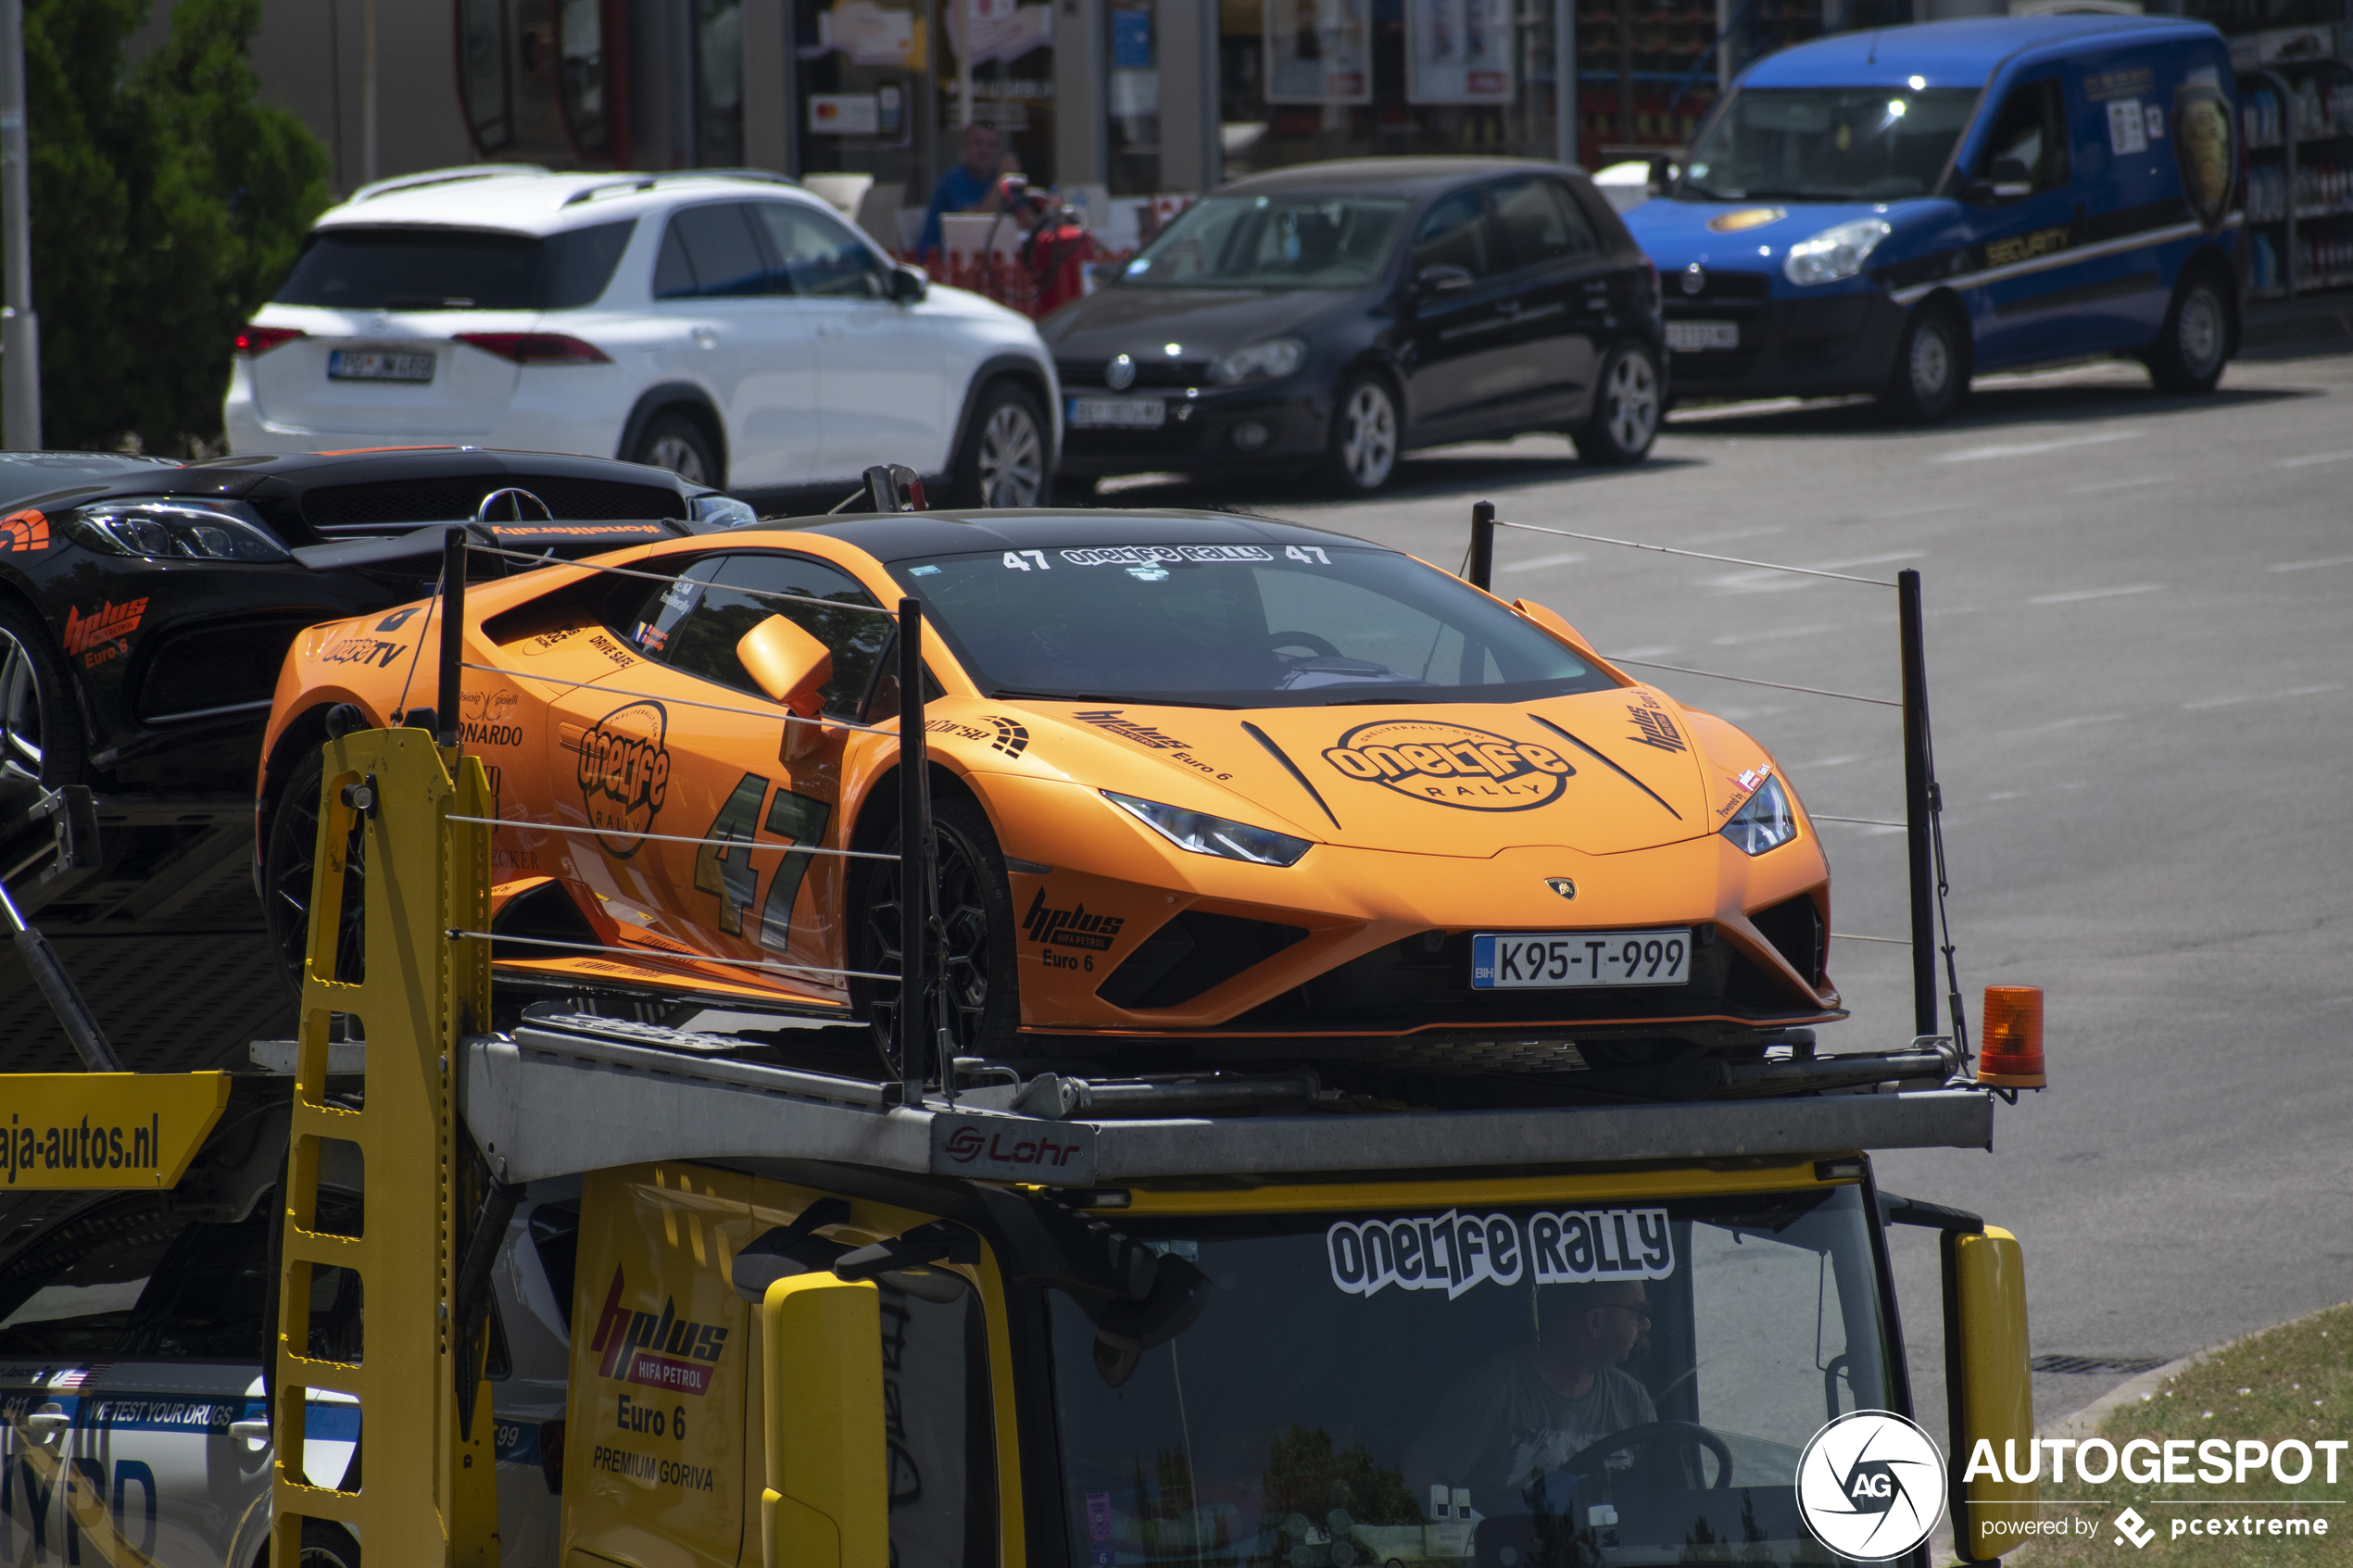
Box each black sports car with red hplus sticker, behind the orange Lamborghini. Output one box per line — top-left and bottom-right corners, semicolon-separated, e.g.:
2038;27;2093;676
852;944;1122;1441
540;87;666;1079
0;446;750;822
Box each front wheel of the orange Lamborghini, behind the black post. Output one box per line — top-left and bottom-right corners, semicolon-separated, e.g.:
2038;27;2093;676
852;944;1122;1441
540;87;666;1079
849;795;1021;1074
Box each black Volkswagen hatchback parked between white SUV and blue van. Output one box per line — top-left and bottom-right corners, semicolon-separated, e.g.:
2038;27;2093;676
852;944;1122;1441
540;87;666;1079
1040;157;1666;494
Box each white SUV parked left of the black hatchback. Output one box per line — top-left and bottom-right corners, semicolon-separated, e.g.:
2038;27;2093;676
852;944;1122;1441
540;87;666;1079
226;165;1062;506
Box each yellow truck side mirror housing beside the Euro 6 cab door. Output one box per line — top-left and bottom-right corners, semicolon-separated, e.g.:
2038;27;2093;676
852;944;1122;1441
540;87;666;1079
760;1274;889;1568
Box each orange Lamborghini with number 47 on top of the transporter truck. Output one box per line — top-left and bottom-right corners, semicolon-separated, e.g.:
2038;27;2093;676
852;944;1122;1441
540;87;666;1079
258;510;1843;1093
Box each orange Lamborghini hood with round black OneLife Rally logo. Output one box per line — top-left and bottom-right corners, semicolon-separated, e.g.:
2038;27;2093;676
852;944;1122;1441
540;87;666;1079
1024;686;1718;856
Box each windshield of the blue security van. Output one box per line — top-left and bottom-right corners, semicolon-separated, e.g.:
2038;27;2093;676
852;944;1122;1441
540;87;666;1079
1675;87;1977;202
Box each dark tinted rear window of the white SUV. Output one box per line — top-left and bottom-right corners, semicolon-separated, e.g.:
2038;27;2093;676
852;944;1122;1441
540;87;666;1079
273;219;637;310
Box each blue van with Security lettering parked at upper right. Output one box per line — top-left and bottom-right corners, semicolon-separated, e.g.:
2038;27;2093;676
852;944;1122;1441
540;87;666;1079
1626;14;2243;420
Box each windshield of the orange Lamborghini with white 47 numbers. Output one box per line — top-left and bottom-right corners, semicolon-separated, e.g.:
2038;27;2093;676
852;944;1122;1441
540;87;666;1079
892;541;1614;708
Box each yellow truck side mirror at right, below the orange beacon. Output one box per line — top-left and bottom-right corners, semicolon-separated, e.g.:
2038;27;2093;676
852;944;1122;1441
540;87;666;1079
1942;1224;2038;1563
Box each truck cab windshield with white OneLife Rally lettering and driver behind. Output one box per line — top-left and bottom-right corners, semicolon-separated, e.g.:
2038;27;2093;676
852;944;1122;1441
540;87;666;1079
1051;1187;1892;1568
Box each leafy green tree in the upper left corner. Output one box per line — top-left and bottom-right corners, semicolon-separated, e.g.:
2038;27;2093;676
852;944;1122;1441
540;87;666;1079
23;0;327;451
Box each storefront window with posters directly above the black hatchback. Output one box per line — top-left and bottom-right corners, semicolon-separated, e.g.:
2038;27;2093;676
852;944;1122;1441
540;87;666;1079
1219;0;1557;179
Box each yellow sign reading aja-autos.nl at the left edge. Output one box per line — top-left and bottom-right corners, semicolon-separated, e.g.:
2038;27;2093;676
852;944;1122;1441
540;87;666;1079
0;1072;228;1192
